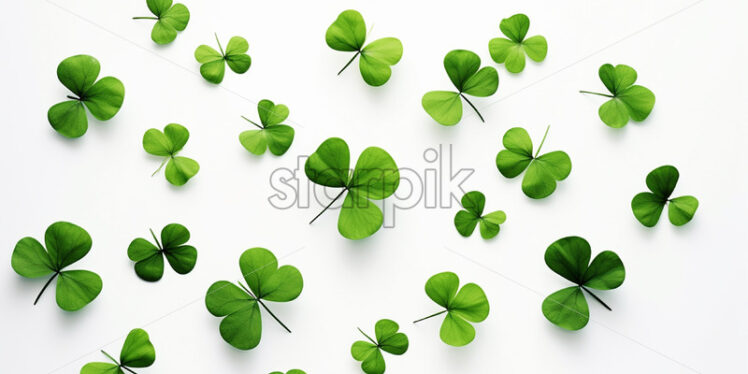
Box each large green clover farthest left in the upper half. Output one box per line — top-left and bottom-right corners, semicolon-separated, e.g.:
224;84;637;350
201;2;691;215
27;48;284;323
47;55;125;138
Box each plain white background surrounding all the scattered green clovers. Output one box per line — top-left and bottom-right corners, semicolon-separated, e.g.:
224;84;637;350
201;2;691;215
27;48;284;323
0;0;748;373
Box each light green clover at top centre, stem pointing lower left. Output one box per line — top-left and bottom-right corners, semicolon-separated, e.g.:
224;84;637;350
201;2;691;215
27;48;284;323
325;10;403;86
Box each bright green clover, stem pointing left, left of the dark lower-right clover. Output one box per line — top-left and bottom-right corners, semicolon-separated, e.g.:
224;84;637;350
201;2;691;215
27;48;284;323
413;271;489;347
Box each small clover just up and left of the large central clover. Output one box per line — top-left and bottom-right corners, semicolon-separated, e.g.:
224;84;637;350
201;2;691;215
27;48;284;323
239;100;294;156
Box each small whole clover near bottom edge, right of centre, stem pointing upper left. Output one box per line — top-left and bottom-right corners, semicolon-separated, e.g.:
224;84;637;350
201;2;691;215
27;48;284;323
351;319;408;374
